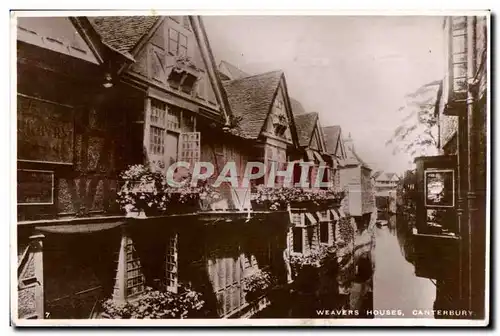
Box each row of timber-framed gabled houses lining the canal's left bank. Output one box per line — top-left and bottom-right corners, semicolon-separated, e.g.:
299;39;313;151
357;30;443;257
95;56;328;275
17;16;362;319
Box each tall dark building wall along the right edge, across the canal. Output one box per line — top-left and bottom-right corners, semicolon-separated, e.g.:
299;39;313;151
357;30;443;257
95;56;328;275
416;16;489;319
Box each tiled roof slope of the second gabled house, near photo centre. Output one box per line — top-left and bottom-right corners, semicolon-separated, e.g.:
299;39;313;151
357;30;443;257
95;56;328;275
223;70;283;139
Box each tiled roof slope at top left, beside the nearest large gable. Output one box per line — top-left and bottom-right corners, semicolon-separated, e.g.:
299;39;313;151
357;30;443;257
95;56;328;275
89;16;161;55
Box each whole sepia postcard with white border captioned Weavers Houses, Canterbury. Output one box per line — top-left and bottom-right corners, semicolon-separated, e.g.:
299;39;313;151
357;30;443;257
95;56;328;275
10;10;491;327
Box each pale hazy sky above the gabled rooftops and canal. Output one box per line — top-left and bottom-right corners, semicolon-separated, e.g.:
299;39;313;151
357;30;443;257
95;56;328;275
203;16;444;172
